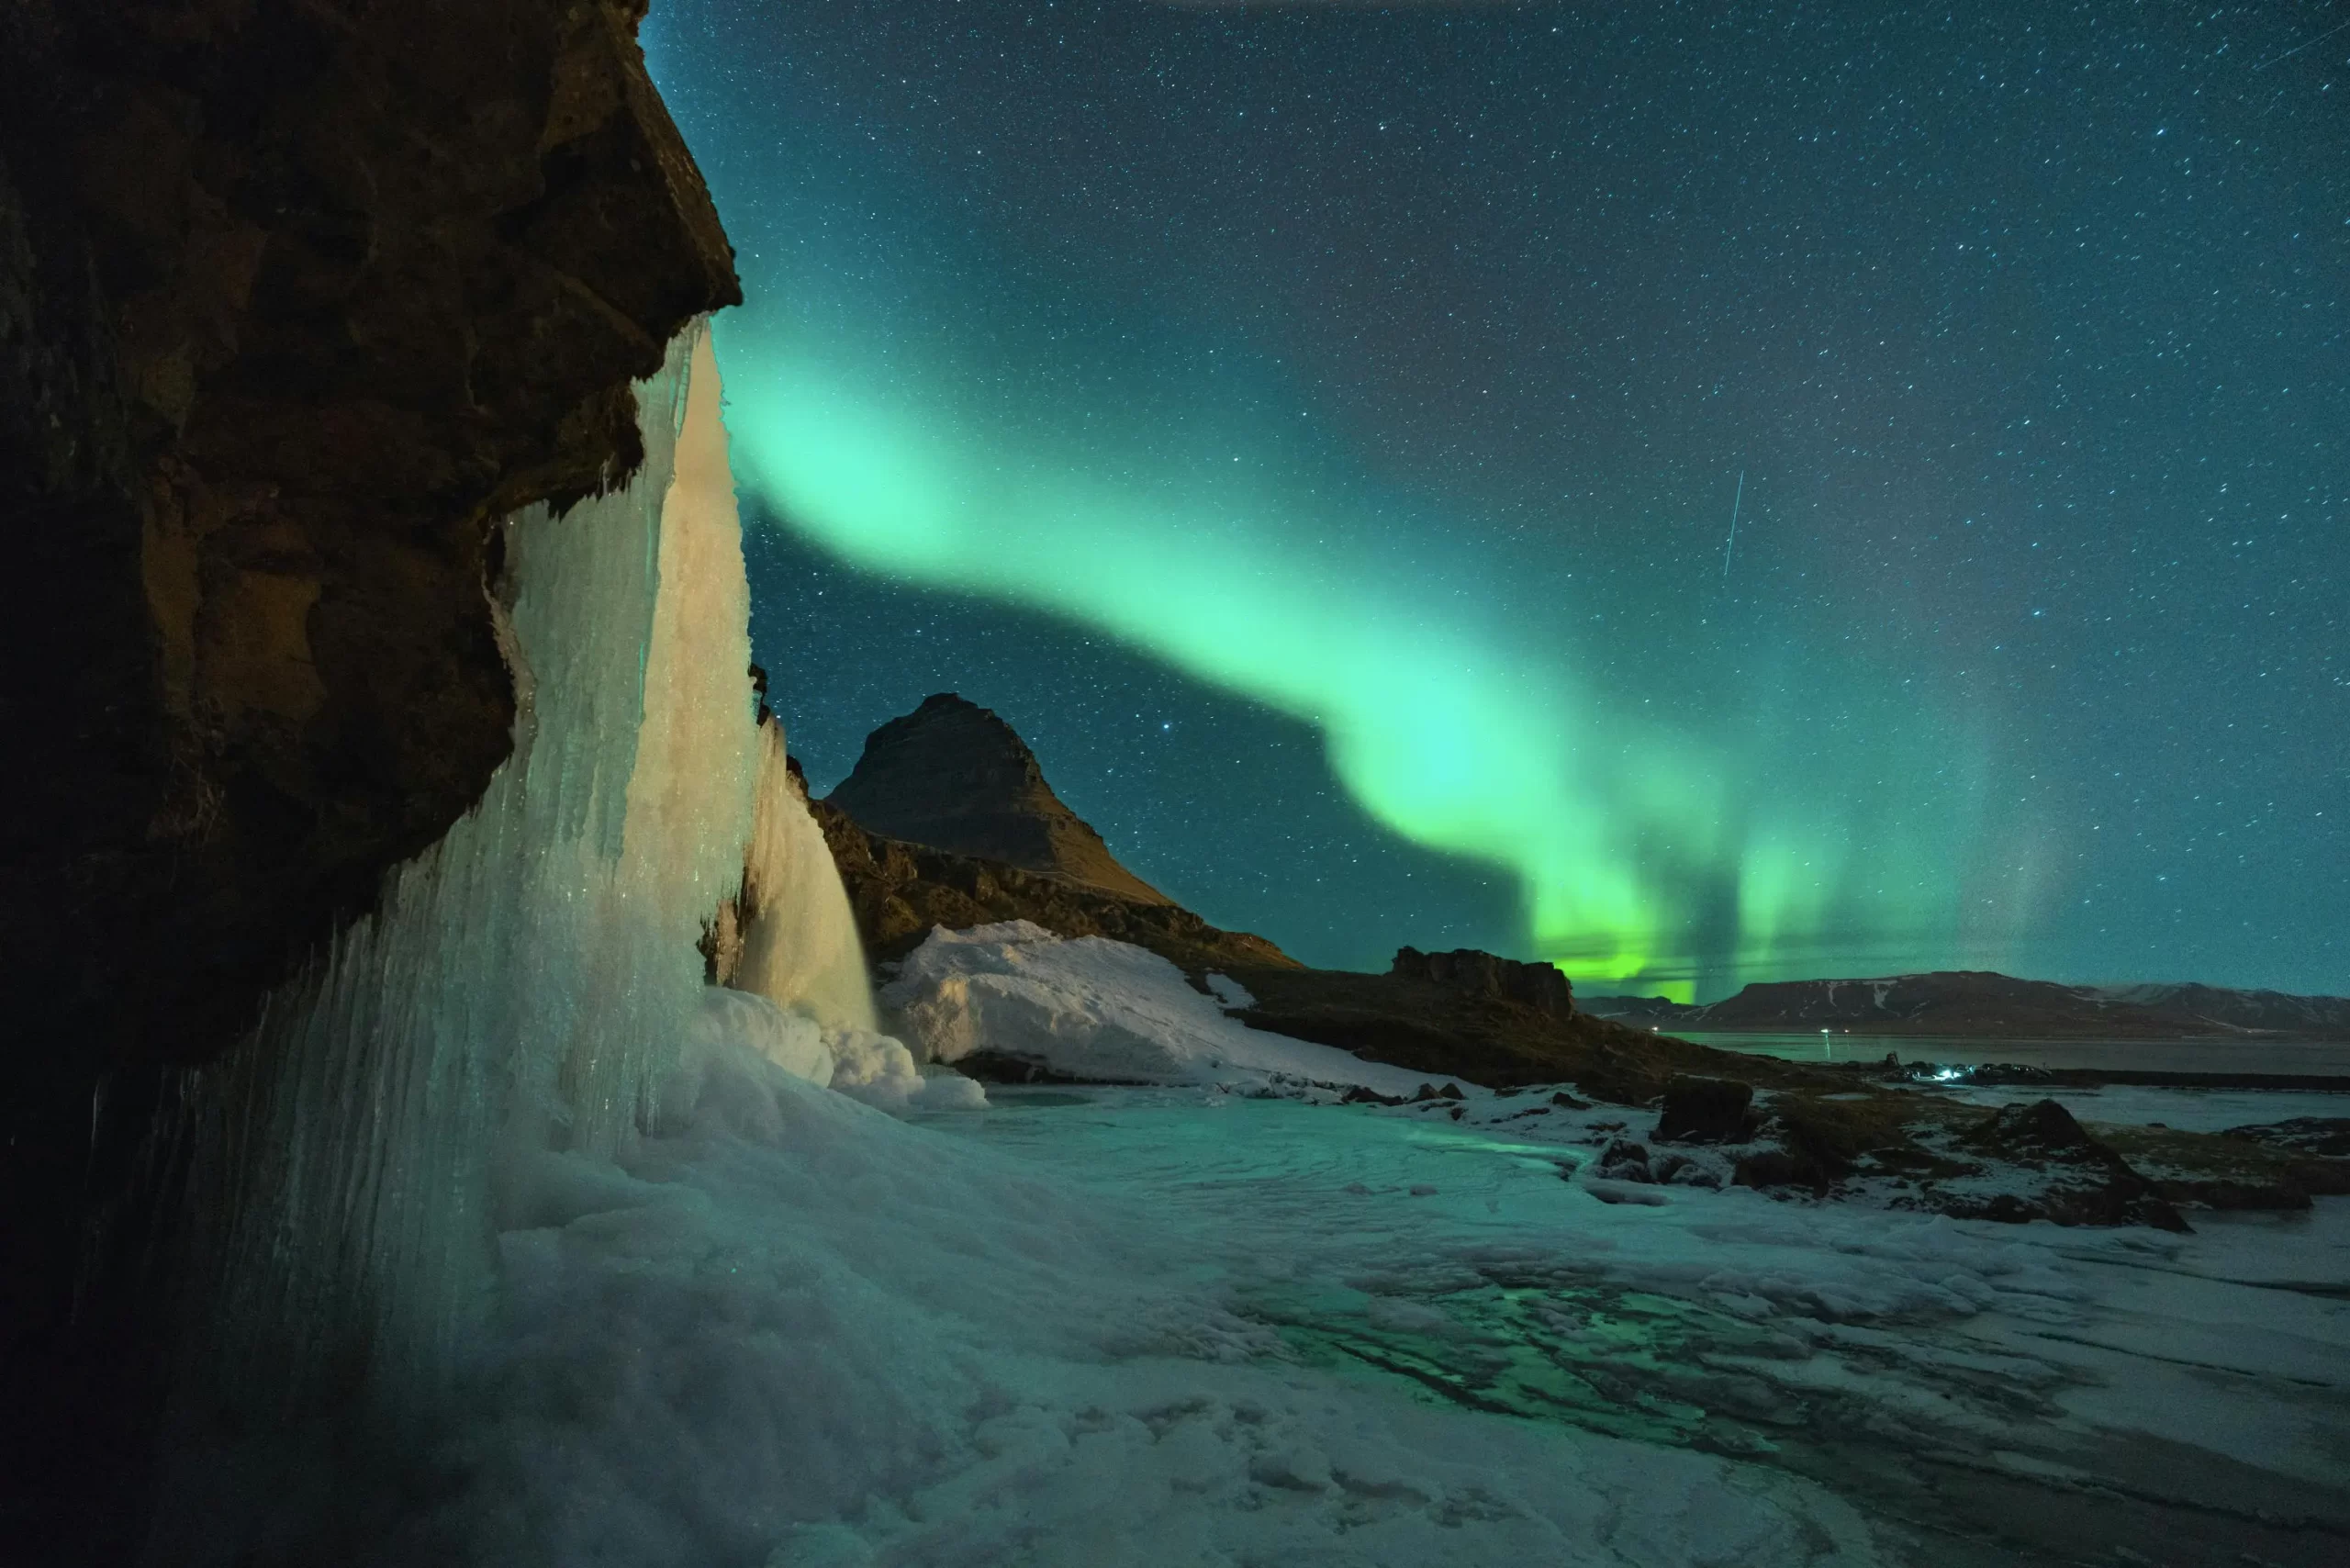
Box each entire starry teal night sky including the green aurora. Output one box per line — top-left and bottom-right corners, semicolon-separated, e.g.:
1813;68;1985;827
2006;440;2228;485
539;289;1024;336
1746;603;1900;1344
646;0;2350;999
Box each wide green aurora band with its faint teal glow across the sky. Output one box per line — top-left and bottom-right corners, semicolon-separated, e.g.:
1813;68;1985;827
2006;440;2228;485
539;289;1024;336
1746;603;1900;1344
677;42;2052;999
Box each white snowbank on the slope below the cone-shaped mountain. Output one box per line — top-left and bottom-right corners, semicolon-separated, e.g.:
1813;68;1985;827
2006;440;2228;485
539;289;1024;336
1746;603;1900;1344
881;919;1443;1093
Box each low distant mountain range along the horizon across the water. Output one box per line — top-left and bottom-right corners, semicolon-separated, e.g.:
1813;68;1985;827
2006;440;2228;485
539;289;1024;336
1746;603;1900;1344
1577;969;2350;1039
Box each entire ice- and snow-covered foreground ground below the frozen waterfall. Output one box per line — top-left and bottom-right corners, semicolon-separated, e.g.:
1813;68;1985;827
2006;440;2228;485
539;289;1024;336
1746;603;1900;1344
350;999;2350;1568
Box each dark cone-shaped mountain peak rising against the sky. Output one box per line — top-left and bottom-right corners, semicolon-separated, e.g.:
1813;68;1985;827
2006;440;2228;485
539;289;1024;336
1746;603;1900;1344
825;691;1168;902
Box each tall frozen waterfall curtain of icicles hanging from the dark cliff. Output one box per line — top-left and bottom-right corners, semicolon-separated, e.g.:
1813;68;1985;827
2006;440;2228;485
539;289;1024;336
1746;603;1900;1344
161;322;761;1429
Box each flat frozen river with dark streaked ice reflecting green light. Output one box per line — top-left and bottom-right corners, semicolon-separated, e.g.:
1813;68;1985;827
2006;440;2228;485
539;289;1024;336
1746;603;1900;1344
902;1091;2350;1563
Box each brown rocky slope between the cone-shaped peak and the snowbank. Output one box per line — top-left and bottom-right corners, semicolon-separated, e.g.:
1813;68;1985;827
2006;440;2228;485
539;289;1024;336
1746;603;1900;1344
811;801;1297;976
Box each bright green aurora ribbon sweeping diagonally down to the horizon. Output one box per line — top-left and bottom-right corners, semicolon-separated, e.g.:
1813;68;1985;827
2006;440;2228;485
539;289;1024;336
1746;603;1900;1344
719;291;1981;999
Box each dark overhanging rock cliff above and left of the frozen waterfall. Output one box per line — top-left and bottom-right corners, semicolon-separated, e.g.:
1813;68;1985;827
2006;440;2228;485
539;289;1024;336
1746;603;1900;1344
0;0;738;1561
